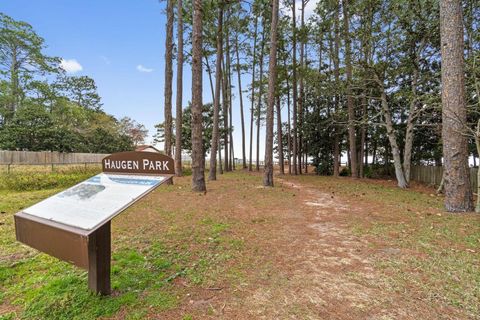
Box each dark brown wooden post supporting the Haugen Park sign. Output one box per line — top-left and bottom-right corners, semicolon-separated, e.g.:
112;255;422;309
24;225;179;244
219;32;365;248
88;221;111;295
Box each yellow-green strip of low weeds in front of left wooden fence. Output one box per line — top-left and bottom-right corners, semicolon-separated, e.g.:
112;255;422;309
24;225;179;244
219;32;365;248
0;168;99;191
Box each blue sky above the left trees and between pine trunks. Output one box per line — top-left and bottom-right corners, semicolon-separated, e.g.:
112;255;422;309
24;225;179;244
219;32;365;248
0;0;317;159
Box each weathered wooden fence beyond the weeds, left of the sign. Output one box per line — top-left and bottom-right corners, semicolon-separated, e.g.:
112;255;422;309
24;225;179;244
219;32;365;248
0;150;108;165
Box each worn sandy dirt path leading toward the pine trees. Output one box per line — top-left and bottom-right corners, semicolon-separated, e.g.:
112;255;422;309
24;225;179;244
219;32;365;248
229;180;386;319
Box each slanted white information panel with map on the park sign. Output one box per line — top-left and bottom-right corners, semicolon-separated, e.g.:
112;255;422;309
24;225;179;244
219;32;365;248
23;173;166;230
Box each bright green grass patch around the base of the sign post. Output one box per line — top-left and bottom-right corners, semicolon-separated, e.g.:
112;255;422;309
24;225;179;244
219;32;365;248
0;246;177;319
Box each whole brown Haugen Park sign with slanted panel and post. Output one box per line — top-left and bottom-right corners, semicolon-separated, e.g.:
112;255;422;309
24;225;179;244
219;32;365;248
15;152;174;295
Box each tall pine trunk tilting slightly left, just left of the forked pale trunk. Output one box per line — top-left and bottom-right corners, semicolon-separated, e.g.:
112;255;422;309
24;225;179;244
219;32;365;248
342;0;358;178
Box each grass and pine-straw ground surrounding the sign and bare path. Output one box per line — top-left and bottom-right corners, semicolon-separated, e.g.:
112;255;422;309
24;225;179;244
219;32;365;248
0;172;480;319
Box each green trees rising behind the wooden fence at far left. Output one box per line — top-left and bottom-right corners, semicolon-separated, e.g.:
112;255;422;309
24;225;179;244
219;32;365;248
0;13;147;153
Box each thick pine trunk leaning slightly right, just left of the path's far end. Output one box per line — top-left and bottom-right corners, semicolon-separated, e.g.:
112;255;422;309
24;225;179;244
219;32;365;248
263;0;278;187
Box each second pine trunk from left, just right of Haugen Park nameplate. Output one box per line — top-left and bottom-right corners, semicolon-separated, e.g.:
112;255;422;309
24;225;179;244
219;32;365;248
175;0;183;177
